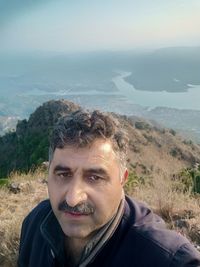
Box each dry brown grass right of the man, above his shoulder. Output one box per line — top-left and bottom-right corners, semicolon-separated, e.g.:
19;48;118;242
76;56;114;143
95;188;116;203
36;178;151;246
132;176;200;248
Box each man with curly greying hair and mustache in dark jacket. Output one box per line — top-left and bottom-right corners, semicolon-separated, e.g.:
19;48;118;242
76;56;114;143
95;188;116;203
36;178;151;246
18;110;200;267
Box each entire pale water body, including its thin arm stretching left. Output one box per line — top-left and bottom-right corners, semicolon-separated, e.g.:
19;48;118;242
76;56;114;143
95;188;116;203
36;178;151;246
21;71;200;110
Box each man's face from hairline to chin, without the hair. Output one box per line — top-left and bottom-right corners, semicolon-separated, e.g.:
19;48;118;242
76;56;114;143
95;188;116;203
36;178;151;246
48;139;126;242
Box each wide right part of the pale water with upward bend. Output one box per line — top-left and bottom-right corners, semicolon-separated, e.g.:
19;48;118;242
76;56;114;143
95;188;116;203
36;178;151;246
112;71;200;110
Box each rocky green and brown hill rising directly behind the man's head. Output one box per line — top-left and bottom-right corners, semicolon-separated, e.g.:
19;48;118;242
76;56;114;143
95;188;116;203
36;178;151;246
0;100;200;178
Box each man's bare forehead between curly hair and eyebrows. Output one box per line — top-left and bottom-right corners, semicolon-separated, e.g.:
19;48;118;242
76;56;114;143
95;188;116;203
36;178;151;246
52;140;116;166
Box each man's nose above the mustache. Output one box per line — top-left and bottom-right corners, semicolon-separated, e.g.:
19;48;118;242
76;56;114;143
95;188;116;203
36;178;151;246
65;180;87;207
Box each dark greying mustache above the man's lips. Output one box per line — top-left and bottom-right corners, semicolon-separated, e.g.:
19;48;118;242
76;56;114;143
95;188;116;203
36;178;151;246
58;201;94;215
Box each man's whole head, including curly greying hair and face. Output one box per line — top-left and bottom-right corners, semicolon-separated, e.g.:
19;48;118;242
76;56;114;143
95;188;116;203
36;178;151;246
48;110;128;239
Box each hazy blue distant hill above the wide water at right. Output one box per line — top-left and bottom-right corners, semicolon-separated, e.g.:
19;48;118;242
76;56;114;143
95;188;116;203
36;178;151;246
126;47;200;92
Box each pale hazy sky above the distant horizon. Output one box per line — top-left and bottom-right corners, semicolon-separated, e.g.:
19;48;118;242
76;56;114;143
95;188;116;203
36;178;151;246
0;0;200;52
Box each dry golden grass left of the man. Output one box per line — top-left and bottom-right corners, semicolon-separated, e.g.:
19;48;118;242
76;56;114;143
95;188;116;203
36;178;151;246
0;170;47;267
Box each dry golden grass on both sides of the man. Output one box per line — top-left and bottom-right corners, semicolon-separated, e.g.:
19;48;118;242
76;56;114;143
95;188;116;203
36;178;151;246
0;170;200;267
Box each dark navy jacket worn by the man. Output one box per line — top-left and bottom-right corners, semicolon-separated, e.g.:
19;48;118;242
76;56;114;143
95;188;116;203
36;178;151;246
18;197;200;267
